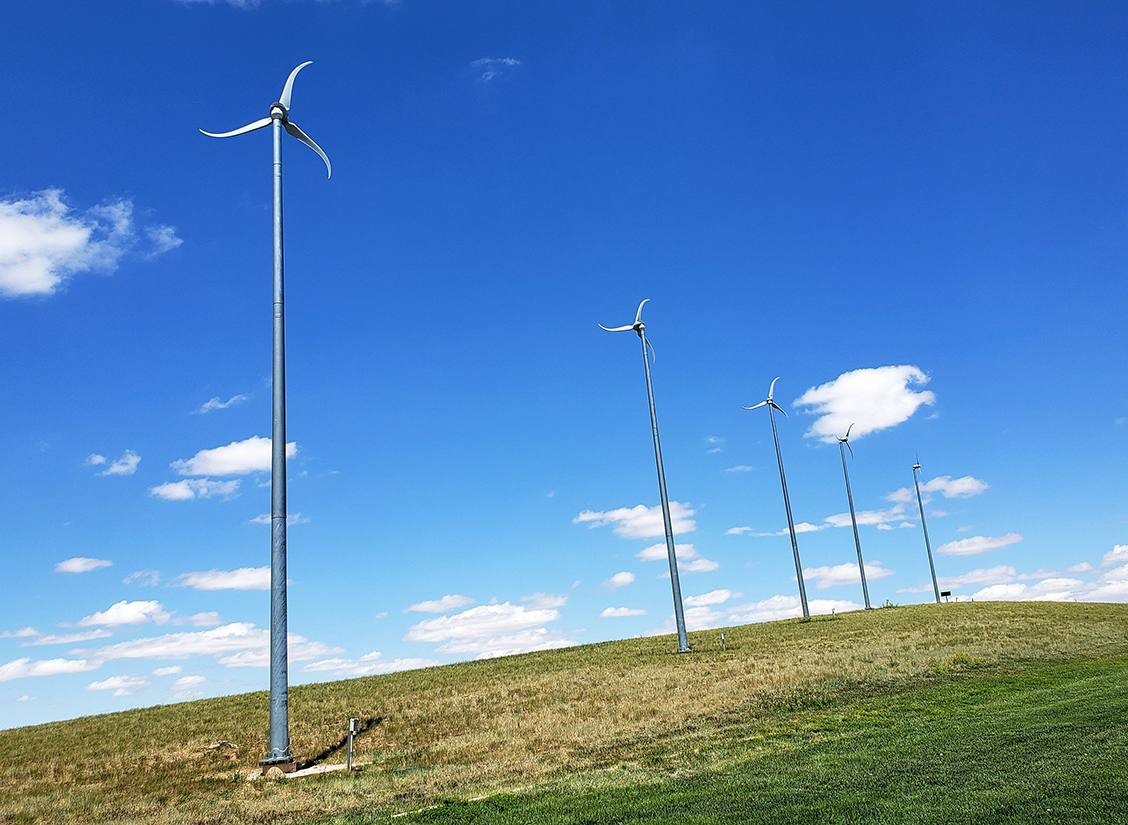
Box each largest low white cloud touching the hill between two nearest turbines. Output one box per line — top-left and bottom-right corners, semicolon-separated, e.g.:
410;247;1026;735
404;602;574;658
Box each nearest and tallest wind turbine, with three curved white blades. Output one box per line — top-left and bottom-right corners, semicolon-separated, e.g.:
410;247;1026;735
200;61;333;771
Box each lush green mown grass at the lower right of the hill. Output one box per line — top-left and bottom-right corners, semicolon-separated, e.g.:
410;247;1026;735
367;658;1128;825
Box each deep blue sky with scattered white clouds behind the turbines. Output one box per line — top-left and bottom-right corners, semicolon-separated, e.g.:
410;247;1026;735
0;0;1128;727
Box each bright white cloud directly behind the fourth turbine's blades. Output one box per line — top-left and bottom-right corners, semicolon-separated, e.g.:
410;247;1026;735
793;366;936;444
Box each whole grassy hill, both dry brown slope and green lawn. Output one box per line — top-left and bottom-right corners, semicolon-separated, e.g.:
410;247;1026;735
0;603;1128;824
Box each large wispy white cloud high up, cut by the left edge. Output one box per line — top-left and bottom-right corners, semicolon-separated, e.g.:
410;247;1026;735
0;190;179;298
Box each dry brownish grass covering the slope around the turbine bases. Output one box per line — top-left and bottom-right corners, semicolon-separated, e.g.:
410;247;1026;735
0;603;1128;824
